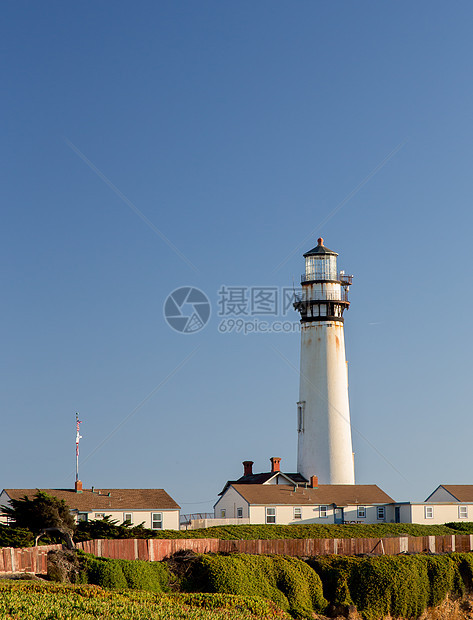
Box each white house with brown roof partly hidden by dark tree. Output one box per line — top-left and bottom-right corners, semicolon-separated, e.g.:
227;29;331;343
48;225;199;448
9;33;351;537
0;481;180;530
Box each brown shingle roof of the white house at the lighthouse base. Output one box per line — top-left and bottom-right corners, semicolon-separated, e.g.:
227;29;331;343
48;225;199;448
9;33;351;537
232;484;394;506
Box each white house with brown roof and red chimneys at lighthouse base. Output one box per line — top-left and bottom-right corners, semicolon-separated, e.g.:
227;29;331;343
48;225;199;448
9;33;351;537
214;457;394;524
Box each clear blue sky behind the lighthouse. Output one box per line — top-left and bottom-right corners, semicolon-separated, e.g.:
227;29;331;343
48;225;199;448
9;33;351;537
0;0;473;512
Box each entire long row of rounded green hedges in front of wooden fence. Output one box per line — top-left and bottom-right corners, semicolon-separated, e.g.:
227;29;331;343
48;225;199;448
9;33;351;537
42;552;473;620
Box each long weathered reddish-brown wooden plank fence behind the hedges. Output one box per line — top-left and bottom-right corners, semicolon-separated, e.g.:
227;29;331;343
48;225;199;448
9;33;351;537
0;534;473;574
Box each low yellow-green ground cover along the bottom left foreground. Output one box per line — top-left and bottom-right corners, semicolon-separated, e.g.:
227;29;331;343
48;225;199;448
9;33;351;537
0;580;288;620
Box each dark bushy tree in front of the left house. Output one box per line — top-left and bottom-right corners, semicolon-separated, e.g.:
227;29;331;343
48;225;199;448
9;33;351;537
1;489;75;534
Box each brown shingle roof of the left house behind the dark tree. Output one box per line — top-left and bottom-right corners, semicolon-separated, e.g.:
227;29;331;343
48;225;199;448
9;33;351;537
4;489;180;512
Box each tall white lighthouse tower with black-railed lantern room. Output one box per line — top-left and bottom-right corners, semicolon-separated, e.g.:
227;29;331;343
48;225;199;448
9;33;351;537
294;238;355;484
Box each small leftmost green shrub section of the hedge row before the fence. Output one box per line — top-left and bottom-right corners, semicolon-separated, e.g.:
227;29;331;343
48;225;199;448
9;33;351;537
77;552;171;592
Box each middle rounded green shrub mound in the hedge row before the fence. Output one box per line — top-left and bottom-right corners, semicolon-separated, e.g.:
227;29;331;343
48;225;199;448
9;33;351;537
181;553;327;618
